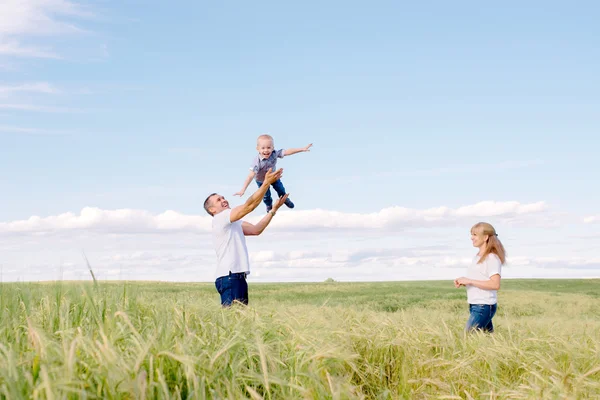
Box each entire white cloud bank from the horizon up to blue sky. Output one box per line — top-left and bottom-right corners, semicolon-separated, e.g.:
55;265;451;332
0;203;600;282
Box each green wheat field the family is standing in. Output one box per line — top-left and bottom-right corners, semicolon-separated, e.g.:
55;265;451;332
0;280;600;399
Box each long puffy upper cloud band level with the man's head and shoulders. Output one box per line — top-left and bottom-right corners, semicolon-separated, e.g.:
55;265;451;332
0;201;547;234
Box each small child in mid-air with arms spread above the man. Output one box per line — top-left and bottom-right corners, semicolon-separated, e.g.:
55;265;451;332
233;135;312;212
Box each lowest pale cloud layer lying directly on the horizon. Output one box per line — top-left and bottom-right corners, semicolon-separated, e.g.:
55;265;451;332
3;249;600;284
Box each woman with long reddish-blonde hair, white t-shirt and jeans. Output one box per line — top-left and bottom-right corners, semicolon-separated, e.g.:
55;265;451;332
454;222;506;332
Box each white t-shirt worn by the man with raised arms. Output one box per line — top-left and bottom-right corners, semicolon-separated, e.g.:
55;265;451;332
213;209;250;278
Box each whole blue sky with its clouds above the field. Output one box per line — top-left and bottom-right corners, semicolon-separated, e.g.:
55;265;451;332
0;0;600;280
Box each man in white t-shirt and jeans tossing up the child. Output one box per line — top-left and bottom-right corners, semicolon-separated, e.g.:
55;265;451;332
204;168;288;307
